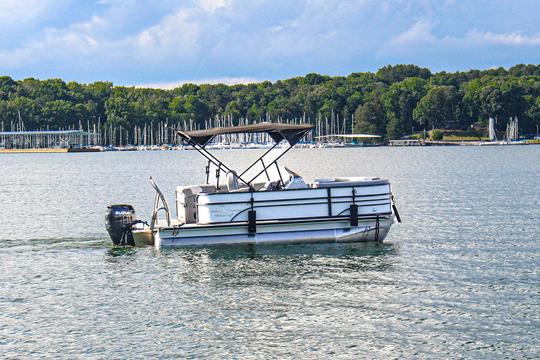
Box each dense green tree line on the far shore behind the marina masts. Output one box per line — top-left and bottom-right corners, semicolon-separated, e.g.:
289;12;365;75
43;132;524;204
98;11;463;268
0;64;540;139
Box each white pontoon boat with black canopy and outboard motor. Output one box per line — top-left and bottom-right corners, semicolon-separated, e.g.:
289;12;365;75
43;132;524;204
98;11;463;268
106;123;399;249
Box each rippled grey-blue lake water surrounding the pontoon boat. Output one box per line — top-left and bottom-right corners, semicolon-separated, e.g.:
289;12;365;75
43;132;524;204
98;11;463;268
0;146;540;359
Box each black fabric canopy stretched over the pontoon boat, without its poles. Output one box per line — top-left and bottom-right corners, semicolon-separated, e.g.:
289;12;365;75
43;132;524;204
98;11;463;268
178;122;313;147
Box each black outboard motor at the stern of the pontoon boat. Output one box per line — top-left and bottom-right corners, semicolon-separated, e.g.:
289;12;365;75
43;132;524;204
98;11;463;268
105;205;135;246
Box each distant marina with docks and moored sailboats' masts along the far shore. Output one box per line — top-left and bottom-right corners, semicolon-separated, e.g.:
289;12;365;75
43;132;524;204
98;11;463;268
0;102;540;154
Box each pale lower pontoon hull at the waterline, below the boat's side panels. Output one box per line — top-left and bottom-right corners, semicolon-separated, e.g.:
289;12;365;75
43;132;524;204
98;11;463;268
154;214;394;249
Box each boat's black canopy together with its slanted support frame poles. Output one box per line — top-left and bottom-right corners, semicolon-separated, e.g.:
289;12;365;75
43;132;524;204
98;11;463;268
178;123;313;189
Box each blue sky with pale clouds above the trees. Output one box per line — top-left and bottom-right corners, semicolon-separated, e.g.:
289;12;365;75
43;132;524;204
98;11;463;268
0;0;540;88
